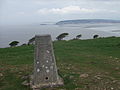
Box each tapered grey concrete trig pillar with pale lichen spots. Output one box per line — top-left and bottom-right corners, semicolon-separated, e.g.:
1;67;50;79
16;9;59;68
31;35;63;90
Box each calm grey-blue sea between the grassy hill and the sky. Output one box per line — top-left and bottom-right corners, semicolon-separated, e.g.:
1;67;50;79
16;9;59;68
0;23;120;48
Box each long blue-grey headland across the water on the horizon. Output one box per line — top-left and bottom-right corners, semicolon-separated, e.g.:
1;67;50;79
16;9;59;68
56;19;120;25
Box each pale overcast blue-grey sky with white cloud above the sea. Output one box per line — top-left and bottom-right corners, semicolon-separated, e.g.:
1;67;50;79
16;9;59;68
0;0;120;25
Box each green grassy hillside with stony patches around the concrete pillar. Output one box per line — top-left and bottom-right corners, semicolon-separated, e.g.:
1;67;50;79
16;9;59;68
0;38;120;90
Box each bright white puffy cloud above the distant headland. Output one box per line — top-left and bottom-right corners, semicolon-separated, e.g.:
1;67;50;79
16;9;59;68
37;6;100;14
